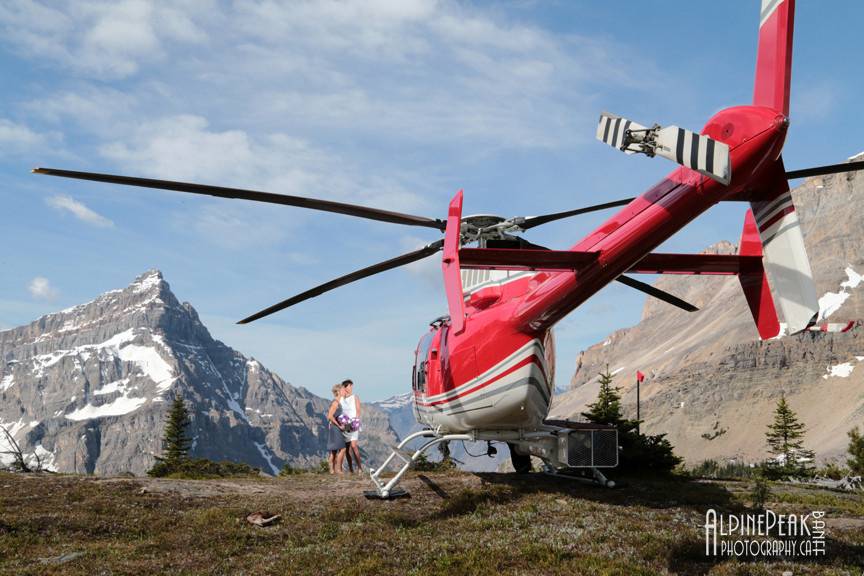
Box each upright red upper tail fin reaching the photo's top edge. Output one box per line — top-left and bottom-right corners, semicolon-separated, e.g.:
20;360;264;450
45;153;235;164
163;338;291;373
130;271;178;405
753;0;795;116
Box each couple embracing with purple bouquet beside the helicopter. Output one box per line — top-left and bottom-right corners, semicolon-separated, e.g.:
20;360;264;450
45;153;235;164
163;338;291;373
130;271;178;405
327;380;362;474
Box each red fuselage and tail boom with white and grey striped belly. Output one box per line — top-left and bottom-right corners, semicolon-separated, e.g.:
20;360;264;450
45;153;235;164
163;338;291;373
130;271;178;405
413;106;788;432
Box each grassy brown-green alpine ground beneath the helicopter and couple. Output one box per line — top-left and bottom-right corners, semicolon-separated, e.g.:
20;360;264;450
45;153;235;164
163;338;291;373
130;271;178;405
0;472;864;576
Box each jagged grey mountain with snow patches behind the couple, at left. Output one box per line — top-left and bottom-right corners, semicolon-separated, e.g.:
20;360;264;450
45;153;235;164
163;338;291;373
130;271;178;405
0;270;396;475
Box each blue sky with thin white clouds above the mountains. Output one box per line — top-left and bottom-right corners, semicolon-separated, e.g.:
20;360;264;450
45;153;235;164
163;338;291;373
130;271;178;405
0;0;864;399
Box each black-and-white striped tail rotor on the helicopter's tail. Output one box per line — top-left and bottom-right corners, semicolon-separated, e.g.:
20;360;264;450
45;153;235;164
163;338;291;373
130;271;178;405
597;112;732;185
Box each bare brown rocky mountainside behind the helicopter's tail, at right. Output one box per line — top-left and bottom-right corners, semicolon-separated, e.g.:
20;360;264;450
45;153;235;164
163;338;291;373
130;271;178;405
552;158;864;463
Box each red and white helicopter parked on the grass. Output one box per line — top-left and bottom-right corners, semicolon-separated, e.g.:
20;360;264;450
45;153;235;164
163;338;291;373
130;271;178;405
34;0;864;497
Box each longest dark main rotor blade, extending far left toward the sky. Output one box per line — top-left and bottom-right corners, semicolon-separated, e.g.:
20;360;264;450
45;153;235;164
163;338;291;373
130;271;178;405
33;168;447;231
